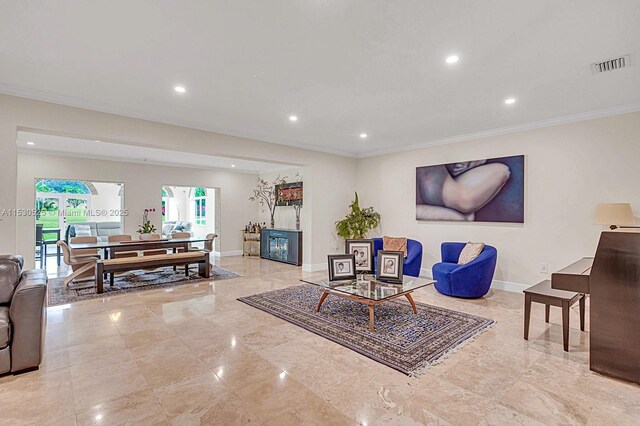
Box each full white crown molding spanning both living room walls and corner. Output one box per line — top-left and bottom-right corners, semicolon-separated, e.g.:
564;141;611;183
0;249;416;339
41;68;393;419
0;83;640;158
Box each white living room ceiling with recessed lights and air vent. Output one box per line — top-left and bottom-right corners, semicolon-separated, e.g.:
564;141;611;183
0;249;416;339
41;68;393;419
0;0;640;156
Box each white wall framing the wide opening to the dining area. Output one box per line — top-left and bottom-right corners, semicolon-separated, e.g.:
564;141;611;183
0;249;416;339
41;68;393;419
0;95;357;269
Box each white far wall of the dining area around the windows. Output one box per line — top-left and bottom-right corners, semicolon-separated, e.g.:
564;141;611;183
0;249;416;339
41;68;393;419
17;152;258;264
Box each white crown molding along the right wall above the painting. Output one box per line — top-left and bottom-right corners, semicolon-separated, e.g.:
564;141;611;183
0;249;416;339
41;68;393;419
356;103;640;158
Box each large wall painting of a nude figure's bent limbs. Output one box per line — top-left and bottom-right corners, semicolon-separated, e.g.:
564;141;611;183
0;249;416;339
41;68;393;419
416;155;524;223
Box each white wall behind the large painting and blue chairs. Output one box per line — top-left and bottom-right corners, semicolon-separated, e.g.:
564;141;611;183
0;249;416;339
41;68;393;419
357;113;640;285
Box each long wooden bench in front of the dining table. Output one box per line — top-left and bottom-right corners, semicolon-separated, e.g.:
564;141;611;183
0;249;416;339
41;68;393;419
96;251;211;293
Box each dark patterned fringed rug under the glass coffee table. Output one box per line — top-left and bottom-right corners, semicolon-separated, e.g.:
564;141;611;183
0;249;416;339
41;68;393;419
238;284;494;375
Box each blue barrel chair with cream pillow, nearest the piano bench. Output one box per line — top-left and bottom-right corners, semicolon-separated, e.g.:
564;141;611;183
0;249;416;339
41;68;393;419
431;243;498;299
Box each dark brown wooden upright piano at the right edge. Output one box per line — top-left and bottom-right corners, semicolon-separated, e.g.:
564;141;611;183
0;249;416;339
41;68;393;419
551;229;640;383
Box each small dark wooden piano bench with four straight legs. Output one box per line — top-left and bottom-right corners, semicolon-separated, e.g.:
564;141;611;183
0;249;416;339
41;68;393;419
524;280;585;352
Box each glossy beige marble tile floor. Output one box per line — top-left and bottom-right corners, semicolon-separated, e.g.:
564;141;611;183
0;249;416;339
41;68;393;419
0;257;640;425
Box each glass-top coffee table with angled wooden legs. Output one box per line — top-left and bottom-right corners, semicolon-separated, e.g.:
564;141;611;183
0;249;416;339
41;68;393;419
300;275;435;331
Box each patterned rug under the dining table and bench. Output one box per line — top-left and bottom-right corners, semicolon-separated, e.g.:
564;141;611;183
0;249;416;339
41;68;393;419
47;265;239;306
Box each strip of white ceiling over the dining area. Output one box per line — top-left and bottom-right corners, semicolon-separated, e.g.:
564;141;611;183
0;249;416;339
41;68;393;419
17;131;291;173
